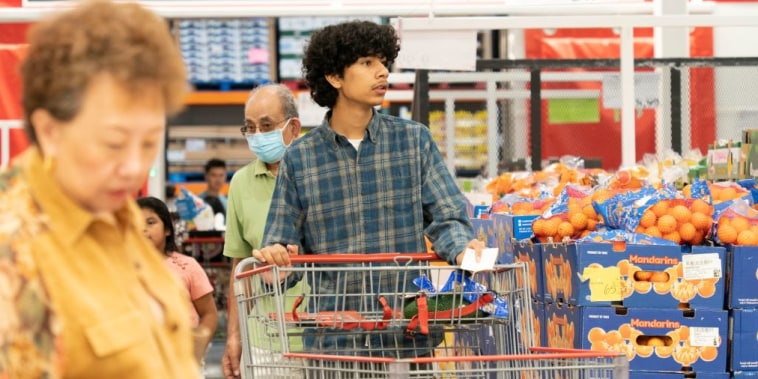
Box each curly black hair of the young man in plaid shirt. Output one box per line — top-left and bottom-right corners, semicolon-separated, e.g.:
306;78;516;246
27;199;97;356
303;21;400;109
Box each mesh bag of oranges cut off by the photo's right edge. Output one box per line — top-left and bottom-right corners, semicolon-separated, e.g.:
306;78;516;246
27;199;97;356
714;201;758;246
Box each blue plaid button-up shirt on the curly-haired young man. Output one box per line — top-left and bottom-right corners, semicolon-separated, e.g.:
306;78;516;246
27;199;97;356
263;112;474;356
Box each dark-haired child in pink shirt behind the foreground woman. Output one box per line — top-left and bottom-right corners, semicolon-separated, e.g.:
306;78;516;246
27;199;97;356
137;197;218;376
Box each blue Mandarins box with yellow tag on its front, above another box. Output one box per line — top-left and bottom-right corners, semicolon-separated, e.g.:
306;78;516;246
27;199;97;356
542;242;726;310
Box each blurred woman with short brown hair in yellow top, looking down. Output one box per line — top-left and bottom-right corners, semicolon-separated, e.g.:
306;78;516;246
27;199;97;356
0;1;199;379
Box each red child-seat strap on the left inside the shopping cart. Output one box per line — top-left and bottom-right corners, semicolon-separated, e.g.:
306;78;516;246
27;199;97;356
292;296;392;330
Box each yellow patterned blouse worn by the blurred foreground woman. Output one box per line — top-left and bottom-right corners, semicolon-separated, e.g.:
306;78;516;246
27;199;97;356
0;148;199;379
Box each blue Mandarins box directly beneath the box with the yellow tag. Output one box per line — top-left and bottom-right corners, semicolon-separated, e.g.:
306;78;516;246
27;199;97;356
545;304;728;372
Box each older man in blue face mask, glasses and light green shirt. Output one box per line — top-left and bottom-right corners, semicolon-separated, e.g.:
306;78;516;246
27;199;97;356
222;84;308;378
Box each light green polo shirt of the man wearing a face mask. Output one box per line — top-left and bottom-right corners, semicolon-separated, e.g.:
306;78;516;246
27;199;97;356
224;160;310;352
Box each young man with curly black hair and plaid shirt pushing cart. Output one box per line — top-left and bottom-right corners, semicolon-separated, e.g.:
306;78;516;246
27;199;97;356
253;21;483;372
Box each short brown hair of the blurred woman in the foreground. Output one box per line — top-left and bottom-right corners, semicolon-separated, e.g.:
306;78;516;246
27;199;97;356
21;1;188;144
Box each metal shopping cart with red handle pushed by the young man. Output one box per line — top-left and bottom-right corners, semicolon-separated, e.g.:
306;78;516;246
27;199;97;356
235;253;628;379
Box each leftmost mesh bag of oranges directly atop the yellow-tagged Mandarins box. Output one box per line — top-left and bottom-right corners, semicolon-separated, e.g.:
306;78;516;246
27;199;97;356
532;184;598;242
